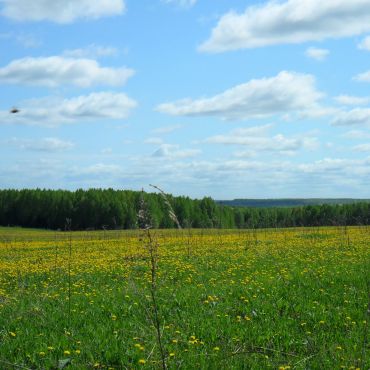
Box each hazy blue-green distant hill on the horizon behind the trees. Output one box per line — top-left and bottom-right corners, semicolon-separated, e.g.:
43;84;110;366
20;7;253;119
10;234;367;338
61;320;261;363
216;198;370;208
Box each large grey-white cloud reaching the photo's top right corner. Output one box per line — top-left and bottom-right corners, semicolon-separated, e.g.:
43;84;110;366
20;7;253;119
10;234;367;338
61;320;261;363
200;0;370;52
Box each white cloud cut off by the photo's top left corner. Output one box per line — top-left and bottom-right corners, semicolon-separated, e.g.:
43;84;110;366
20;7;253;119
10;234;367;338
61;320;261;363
0;0;125;23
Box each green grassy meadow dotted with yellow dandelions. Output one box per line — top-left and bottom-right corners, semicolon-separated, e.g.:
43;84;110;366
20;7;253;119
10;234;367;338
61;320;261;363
0;227;370;369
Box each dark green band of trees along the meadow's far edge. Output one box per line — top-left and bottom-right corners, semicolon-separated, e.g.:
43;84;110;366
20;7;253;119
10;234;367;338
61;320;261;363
0;189;370;230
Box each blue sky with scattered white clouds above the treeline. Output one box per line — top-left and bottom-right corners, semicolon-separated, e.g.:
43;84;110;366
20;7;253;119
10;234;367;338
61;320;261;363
0;0;370;199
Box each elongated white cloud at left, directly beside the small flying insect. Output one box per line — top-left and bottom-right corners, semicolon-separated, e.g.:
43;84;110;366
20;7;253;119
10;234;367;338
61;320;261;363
0;92;137;127
